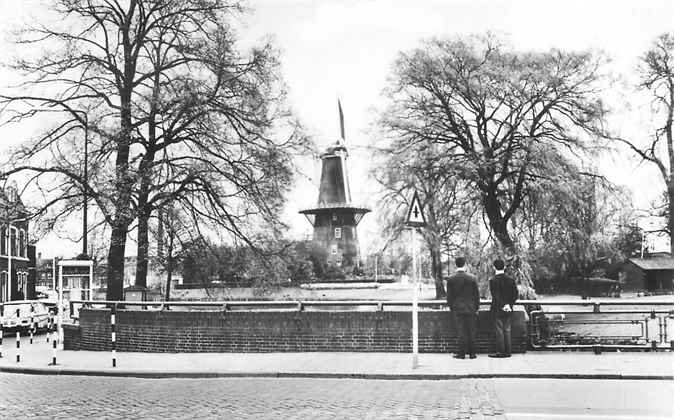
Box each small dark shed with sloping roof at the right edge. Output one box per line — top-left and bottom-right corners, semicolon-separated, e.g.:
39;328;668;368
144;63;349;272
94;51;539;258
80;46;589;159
625;255;674;293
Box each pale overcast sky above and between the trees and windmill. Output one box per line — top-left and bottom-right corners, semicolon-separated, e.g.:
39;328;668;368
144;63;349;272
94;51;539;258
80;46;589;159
0;0;674;255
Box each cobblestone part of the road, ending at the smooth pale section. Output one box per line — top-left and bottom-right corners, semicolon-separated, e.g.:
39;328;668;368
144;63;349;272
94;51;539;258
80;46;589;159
0;373;505;419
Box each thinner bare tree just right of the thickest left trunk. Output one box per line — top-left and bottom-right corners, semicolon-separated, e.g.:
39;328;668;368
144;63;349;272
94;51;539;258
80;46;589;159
126;5;305;285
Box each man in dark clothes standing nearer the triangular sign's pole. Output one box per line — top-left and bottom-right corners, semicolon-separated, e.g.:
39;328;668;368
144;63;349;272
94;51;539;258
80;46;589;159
447;257;480;359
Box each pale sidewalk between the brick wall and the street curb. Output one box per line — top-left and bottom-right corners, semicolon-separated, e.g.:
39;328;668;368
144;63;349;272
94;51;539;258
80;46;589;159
0;335;674;380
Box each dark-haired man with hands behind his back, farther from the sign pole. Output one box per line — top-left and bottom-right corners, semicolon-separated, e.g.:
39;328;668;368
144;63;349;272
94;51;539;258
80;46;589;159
489;259;518;357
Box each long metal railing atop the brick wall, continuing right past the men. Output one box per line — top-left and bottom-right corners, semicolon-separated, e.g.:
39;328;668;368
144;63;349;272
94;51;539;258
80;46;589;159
64;299;674;352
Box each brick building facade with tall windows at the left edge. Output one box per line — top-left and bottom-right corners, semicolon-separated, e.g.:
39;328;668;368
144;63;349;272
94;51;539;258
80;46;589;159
0;187;35;302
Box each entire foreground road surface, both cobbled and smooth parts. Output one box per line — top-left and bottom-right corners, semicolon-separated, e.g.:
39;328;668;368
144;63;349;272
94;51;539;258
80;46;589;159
0;373;674;420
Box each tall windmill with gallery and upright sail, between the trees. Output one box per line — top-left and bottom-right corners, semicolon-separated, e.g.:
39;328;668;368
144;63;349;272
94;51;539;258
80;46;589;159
300;101;370;272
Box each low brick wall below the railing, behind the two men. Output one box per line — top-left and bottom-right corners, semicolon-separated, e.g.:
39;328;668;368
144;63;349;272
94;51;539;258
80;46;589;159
64;309;527;353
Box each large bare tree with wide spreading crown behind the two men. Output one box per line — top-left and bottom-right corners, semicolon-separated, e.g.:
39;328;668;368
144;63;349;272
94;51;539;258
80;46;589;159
380;35;605;288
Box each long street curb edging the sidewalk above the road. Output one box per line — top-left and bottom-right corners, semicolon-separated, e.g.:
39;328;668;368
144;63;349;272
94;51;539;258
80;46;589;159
0;366;674;381
